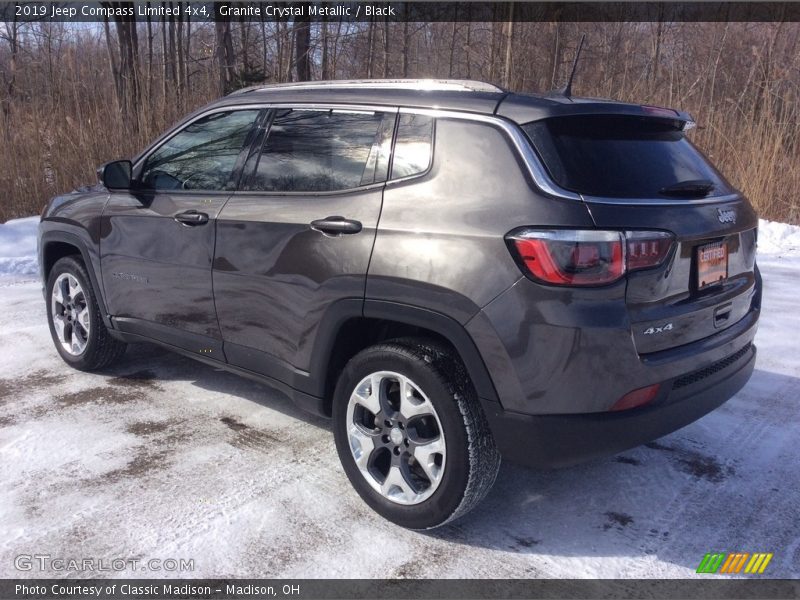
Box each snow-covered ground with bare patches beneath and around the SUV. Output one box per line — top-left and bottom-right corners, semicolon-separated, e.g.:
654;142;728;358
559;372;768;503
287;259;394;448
0;219;800;578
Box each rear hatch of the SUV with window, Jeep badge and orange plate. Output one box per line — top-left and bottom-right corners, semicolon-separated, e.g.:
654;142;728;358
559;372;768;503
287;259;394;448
523;109;758;355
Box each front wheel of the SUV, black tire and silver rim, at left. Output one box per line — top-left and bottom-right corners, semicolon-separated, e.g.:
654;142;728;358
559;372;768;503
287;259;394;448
45;256;127;371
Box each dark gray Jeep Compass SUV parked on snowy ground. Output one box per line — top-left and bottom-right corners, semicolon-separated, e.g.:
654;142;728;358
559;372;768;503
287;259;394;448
39;80;761;529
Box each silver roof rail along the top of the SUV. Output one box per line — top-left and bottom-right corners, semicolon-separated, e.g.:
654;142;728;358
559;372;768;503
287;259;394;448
228;79;505;96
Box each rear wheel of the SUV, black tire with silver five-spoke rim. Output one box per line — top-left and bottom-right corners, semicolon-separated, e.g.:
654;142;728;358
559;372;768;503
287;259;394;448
333;338;500;529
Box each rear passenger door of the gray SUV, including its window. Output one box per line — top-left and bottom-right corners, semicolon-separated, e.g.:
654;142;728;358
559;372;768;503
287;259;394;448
213;106;396;390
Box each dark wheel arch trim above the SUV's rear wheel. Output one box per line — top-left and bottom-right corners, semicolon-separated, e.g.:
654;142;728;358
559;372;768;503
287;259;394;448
309;299;497;416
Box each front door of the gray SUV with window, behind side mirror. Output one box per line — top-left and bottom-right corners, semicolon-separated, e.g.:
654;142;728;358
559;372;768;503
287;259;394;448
100;109;260;360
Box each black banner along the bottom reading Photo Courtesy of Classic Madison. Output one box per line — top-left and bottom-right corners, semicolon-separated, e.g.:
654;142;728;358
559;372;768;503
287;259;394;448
0;578;800;600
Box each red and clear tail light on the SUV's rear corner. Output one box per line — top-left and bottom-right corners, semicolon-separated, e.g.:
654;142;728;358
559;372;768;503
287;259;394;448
507;228;673;286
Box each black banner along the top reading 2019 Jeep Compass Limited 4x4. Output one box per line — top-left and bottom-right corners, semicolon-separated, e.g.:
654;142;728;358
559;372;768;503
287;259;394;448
0;1;800;22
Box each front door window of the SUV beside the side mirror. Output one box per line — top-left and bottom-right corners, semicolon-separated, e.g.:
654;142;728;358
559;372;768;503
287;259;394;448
139;110;259;191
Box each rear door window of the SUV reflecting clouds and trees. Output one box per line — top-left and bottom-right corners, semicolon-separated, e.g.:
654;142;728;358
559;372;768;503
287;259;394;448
247;109;394;192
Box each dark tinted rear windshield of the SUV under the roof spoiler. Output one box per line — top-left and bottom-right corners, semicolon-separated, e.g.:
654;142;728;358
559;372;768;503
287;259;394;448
523;115;730;198
